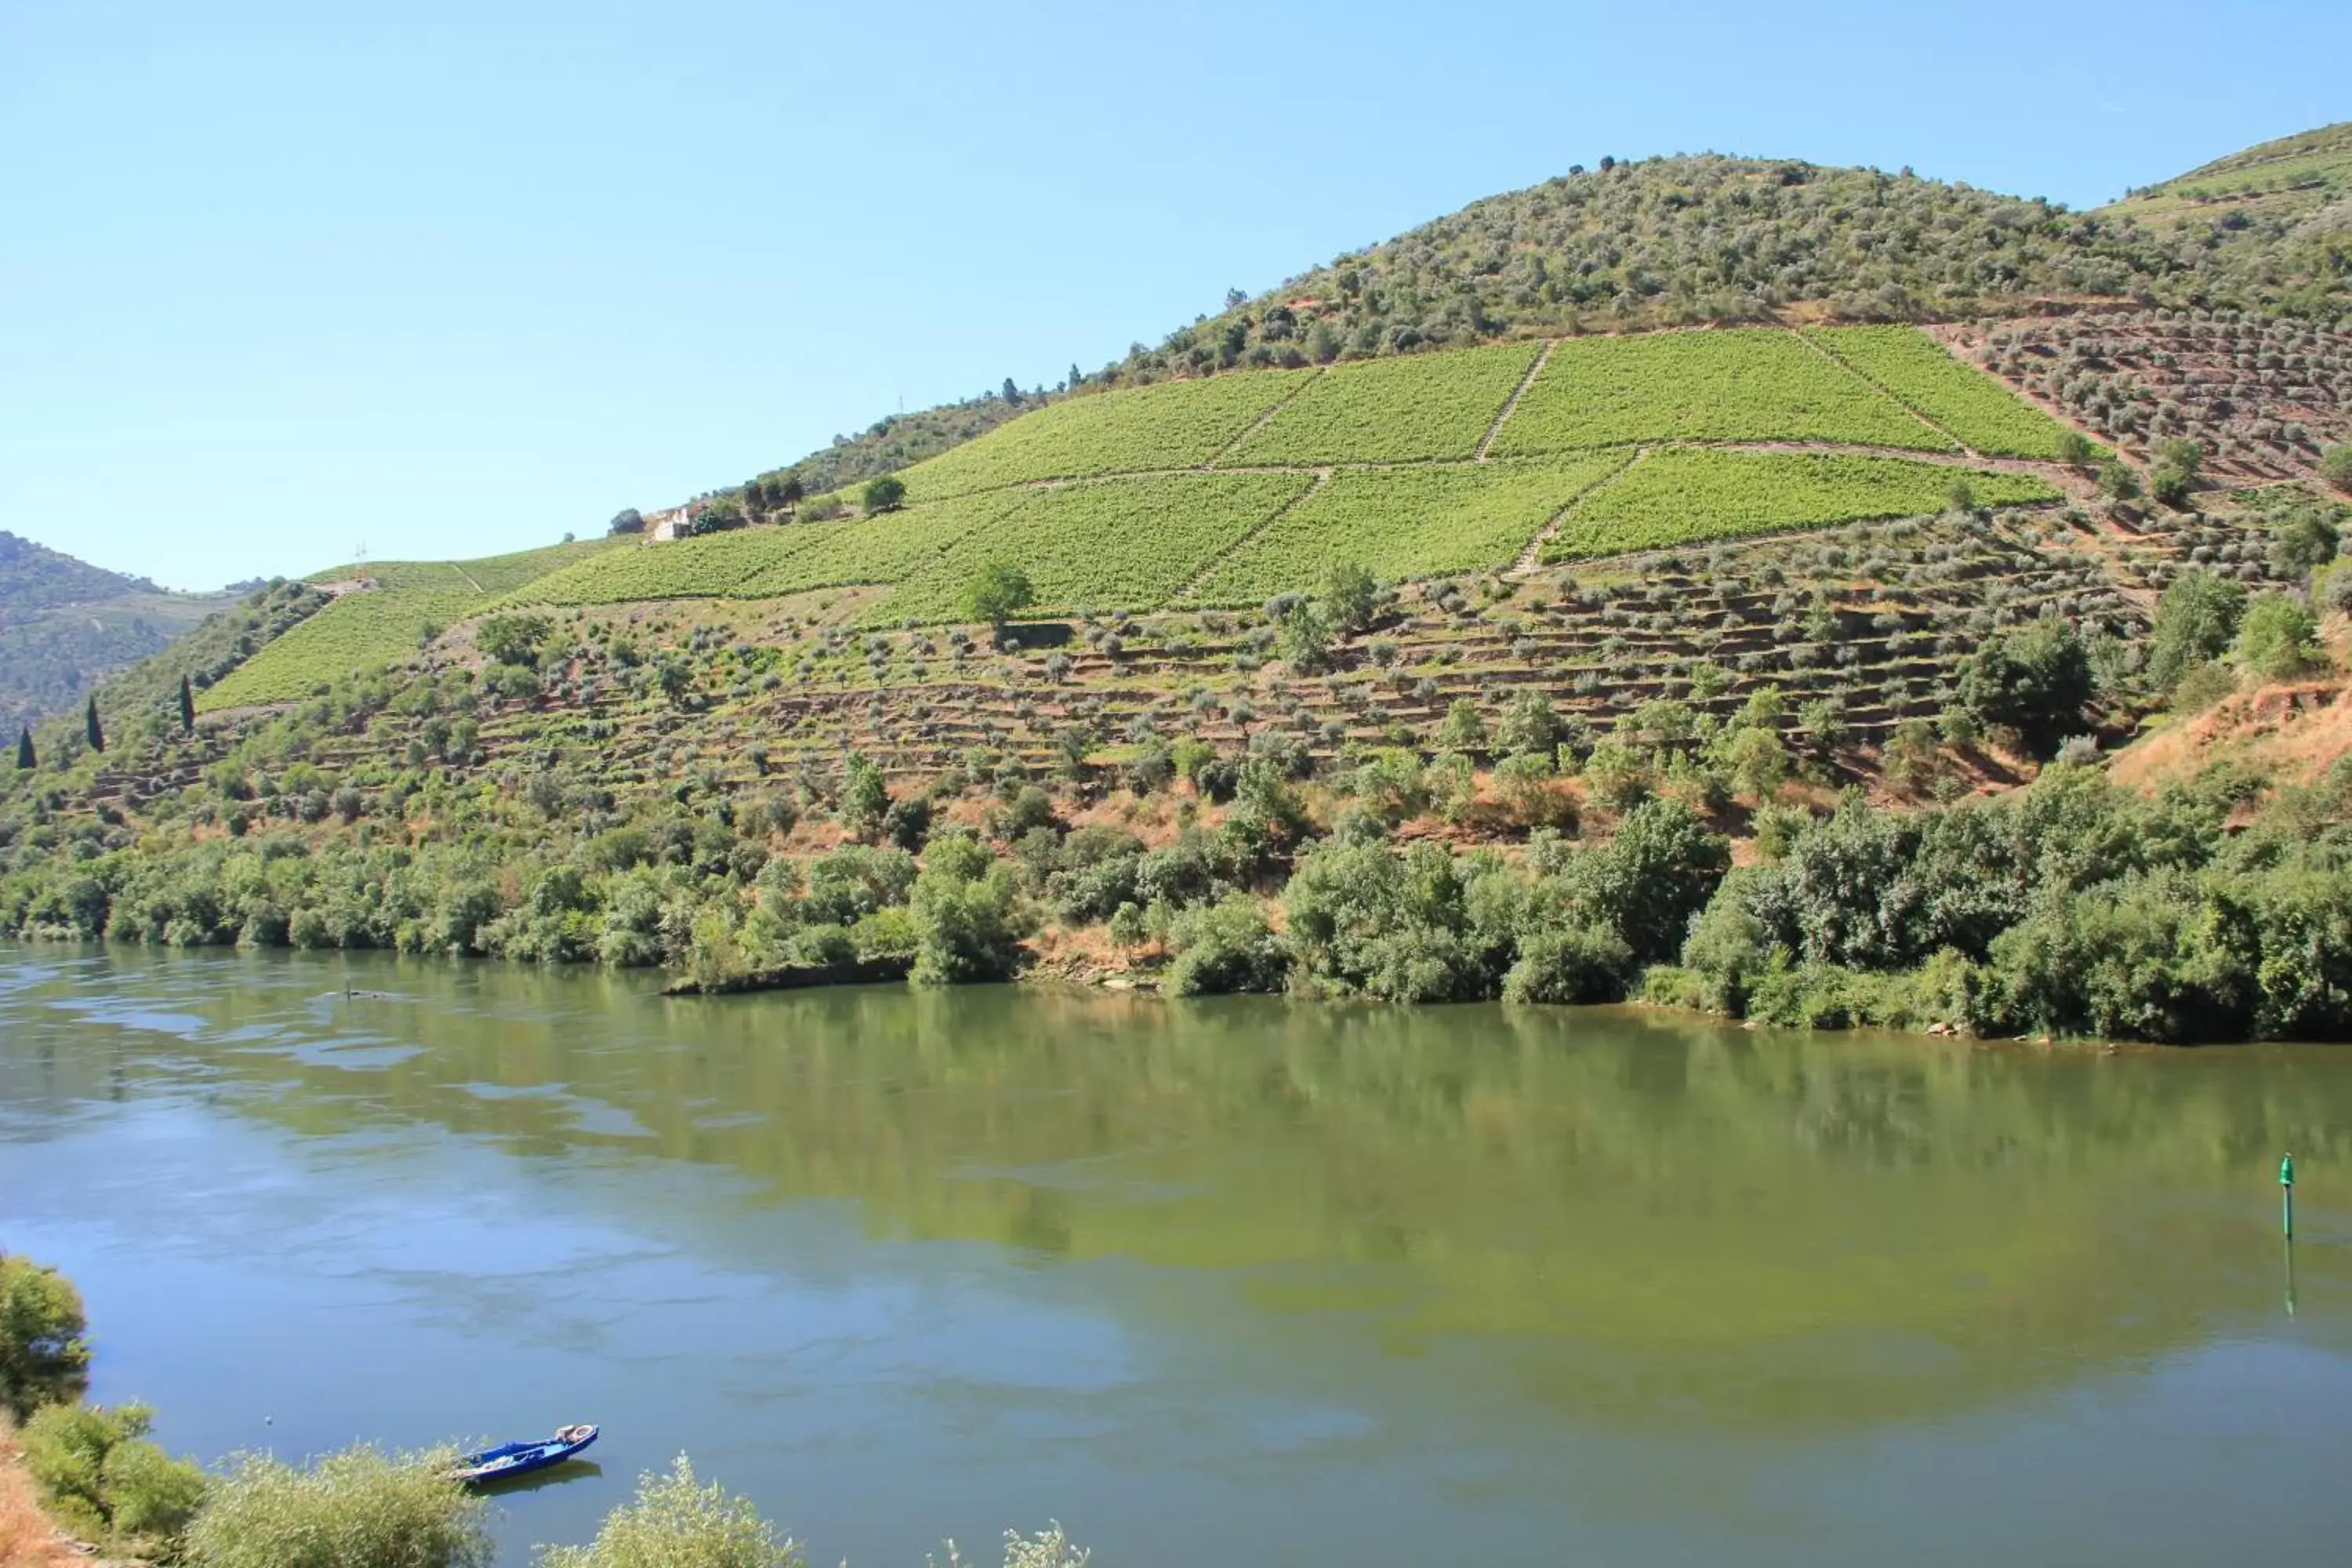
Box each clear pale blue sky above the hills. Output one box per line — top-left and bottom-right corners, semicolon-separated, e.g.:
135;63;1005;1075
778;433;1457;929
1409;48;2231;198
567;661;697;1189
0;0;2352;588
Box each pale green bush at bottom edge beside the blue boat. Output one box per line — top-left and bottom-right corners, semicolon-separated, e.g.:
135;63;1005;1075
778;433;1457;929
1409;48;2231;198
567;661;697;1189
186;1446;492;1568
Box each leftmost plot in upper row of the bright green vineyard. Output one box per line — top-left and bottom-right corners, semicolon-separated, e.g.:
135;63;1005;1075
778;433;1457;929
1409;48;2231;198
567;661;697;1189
903;372;1317;501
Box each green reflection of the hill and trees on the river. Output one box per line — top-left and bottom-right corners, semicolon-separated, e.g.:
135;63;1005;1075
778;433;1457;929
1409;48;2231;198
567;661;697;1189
13;956;2352;1420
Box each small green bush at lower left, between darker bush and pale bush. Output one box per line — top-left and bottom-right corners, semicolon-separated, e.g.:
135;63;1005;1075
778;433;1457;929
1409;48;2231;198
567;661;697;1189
24;1403;205;1563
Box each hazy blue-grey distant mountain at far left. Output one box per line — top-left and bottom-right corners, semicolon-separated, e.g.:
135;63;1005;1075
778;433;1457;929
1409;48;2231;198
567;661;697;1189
0;532;233;731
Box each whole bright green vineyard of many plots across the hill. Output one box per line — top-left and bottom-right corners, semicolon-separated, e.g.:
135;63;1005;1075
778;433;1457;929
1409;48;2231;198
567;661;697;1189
437;327;2082;644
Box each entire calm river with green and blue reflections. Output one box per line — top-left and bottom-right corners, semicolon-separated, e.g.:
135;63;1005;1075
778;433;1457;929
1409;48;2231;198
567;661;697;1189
0;947;2352;1568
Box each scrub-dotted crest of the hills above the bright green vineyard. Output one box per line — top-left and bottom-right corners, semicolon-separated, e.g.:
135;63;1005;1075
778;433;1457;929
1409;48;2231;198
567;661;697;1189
729;138;2352;524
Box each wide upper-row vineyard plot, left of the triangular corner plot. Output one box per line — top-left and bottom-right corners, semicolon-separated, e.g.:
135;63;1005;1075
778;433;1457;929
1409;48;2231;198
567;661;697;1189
1496;327;1957;456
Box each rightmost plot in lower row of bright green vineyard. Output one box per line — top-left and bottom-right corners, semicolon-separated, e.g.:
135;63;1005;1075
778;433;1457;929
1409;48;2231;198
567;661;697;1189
1543;449;2058;562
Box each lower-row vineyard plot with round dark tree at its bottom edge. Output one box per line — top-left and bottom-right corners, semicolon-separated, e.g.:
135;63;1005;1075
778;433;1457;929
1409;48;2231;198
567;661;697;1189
873;473;1312;623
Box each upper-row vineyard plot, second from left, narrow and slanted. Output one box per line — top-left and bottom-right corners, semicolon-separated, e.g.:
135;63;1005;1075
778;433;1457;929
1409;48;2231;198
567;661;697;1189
1232;343;1538;463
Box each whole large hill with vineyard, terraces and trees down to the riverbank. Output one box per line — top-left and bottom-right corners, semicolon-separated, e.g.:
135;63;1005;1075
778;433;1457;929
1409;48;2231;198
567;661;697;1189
0;122;2352;1036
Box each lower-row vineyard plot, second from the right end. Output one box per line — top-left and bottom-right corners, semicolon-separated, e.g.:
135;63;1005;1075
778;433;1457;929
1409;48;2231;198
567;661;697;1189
1190;454;1625;604
